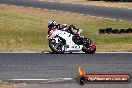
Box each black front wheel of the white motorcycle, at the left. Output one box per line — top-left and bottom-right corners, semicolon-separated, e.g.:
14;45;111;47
49;39;64;54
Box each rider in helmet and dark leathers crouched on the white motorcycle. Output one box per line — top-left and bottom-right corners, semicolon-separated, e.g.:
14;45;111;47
48;20;80;36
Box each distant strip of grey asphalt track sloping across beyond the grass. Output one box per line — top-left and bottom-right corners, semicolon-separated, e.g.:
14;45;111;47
0;0;132;21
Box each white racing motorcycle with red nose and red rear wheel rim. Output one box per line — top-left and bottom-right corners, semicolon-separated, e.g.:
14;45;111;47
48;28;96;54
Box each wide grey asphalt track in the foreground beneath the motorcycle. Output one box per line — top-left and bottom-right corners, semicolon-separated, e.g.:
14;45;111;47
0;53;132;88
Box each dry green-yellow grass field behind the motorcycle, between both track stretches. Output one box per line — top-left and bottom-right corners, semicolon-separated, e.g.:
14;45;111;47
0;5;132;51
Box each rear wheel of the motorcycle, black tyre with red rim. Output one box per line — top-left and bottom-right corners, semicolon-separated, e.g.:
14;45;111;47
82;43;96;54
